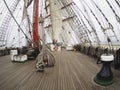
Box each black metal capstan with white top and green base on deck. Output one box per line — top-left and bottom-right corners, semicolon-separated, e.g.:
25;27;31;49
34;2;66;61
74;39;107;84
94;53;114;85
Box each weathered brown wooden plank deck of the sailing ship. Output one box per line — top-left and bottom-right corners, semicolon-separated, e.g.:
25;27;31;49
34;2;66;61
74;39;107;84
0;50;120;90
